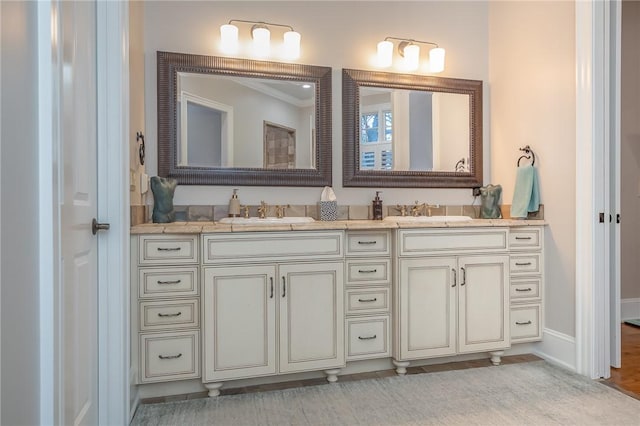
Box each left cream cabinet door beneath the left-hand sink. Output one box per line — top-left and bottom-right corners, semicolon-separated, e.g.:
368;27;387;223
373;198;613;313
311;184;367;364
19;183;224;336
202;265;278;382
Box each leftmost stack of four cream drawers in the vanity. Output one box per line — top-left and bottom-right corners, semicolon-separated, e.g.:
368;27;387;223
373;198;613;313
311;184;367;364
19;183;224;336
131;234;200;383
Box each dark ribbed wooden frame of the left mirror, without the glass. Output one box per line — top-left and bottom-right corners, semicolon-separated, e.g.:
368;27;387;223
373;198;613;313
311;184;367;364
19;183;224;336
157;51;331;186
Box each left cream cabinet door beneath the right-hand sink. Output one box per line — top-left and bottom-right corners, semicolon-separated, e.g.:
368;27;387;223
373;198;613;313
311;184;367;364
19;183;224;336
397;257;459;360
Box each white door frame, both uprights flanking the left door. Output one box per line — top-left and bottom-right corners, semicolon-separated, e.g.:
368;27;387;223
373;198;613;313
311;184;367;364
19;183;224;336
37;0;130;425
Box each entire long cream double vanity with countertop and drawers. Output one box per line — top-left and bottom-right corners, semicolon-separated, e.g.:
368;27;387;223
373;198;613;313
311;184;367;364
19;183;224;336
131;216;544;396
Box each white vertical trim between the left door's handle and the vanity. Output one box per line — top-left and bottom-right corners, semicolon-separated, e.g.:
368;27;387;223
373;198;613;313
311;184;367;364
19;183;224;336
97;1;130;425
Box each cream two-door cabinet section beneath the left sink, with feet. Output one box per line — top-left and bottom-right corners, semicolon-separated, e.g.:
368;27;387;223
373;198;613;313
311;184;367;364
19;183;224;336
202;231;345;396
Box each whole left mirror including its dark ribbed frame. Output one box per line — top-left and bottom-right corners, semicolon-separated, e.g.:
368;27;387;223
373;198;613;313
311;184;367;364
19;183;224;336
157;52;331;186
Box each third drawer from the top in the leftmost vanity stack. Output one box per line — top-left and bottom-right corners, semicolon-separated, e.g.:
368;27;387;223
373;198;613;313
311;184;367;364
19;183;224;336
140;299;200;331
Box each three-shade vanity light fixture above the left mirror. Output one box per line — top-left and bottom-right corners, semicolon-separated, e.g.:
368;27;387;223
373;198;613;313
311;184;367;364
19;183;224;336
220;19;300;59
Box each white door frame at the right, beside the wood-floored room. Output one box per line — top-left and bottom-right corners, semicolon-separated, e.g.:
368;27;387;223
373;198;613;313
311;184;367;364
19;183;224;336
576;0;620;379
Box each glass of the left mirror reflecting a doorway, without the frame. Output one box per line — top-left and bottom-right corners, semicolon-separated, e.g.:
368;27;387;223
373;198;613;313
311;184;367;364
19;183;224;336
176;72;316;169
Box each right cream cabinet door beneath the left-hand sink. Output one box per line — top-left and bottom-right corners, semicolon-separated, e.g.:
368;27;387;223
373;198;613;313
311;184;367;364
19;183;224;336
278;262;345;373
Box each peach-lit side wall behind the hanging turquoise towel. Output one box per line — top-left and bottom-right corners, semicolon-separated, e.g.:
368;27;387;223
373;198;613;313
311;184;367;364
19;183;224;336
487;1;576;336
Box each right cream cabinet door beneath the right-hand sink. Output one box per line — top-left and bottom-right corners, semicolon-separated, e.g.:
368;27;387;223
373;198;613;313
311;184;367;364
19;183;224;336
458;255;510;352
